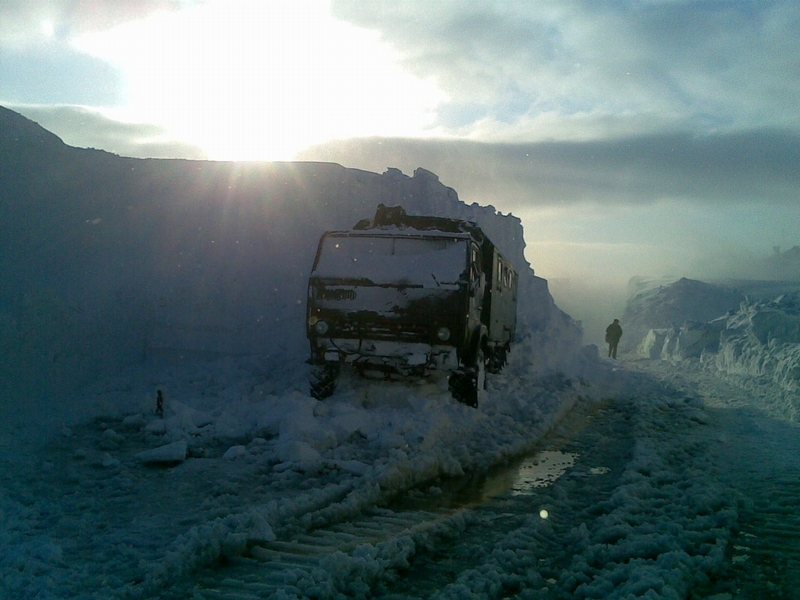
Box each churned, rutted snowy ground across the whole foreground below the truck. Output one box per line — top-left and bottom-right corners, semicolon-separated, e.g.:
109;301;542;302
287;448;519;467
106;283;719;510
6;340;800;599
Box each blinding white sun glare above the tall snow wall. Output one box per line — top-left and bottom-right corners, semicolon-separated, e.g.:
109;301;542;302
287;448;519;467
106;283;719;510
71;0;441;160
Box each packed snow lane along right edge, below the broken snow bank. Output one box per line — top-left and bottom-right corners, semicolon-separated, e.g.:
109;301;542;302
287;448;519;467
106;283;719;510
628;361;800;600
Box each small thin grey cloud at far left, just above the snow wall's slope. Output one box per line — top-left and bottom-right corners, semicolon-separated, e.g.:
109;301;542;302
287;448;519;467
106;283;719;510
8;105;206;159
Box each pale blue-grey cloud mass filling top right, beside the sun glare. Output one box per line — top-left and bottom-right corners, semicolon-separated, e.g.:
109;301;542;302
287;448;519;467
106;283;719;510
333;0;800;140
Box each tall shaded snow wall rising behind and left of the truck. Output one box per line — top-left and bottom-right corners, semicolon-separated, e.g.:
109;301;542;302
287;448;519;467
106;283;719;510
0;108;582;401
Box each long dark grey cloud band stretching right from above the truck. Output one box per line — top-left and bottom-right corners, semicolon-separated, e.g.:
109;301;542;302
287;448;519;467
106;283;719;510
297;131;800;210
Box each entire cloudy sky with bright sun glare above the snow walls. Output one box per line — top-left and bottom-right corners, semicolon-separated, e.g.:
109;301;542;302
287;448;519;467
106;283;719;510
0;0;800;324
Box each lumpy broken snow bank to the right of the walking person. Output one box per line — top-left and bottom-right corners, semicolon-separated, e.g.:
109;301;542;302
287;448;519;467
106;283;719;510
625;279;800;408
